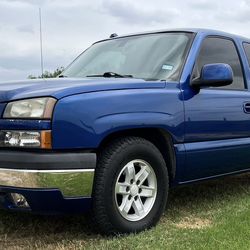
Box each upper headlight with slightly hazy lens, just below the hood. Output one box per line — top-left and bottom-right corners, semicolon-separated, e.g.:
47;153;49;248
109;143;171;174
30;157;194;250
3;97;56;119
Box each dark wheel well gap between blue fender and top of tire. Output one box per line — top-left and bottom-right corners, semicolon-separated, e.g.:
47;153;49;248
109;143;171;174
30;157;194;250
97;128;176;181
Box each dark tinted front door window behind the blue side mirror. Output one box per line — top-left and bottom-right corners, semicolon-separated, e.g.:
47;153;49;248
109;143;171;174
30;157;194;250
194;37;245;89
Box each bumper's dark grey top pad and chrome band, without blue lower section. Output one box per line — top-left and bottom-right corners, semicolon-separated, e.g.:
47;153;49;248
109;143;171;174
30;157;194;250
0;151;96;198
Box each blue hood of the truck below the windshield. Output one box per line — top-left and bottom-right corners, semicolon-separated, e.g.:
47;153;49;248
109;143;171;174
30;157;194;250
0;78;165;102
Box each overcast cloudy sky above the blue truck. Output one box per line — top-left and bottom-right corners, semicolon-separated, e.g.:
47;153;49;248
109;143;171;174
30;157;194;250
0;0;250;81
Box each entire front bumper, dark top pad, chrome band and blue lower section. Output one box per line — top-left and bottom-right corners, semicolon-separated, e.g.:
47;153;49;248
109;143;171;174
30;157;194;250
0;151;96;213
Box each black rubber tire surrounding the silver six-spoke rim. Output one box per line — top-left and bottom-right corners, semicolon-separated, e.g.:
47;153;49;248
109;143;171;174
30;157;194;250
104;143;168;232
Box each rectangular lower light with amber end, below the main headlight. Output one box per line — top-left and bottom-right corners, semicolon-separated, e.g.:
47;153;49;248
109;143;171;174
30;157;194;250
0;130;51;148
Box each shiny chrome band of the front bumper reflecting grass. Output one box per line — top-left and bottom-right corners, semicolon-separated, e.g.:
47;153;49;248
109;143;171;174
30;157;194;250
0;168;95;197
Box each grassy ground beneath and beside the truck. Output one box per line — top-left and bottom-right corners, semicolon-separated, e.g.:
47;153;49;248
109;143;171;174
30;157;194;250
0;174;250;250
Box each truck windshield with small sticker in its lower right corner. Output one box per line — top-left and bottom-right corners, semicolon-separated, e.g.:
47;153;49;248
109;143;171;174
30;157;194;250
62;33;192;81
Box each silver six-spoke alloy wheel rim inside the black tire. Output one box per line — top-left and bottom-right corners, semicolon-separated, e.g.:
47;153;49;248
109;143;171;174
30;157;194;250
115;160;157;221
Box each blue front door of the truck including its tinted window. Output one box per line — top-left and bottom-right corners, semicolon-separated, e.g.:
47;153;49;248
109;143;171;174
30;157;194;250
183;36;250;181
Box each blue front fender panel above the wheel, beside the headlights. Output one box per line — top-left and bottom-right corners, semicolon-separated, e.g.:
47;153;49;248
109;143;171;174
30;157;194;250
52;88;184;149
